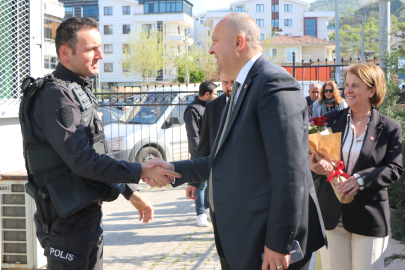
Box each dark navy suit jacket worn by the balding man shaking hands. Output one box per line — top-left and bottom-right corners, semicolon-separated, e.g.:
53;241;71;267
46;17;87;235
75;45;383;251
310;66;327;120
174;56;326;270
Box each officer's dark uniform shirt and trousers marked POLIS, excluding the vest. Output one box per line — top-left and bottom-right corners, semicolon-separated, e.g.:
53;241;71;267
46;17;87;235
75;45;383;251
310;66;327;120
20;63;141;269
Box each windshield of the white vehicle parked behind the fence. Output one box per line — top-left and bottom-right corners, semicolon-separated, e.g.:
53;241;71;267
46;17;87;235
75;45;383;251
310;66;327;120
119;93;177;124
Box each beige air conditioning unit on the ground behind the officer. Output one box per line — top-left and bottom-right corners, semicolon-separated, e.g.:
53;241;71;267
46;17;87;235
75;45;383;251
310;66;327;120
0;178;46;269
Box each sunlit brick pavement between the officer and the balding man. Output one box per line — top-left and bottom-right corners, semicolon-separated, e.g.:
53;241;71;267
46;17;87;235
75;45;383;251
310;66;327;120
103;184;220;270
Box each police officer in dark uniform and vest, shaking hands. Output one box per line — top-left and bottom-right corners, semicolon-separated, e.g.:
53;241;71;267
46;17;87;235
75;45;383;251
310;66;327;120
20;17;181;269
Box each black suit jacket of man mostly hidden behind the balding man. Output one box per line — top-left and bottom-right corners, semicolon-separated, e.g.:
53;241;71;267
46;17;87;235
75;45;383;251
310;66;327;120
190;94;226;187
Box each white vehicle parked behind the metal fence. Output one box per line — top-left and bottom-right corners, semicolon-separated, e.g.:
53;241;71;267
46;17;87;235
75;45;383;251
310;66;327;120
104;89;195;162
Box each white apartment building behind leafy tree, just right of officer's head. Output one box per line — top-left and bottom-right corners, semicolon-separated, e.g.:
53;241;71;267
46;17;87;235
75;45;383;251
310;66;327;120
99;0;194;89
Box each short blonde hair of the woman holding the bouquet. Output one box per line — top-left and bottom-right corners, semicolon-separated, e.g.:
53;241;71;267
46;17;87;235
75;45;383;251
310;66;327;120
343;63;387;107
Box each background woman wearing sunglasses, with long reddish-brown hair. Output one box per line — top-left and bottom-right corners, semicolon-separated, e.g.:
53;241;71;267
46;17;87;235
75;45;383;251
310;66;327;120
312;81;347;117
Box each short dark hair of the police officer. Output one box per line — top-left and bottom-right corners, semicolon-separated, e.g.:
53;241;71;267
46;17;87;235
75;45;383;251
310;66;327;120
55;17;98;57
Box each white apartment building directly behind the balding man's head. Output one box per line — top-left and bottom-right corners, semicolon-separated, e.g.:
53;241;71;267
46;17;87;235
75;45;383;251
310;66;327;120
194;0;334;49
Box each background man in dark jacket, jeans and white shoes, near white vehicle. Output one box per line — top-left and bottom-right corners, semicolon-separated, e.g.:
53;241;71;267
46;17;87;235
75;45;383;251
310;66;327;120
184;81;218;227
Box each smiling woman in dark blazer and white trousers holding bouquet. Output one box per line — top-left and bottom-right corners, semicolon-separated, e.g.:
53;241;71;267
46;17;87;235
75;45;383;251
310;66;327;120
310;64;403;270
